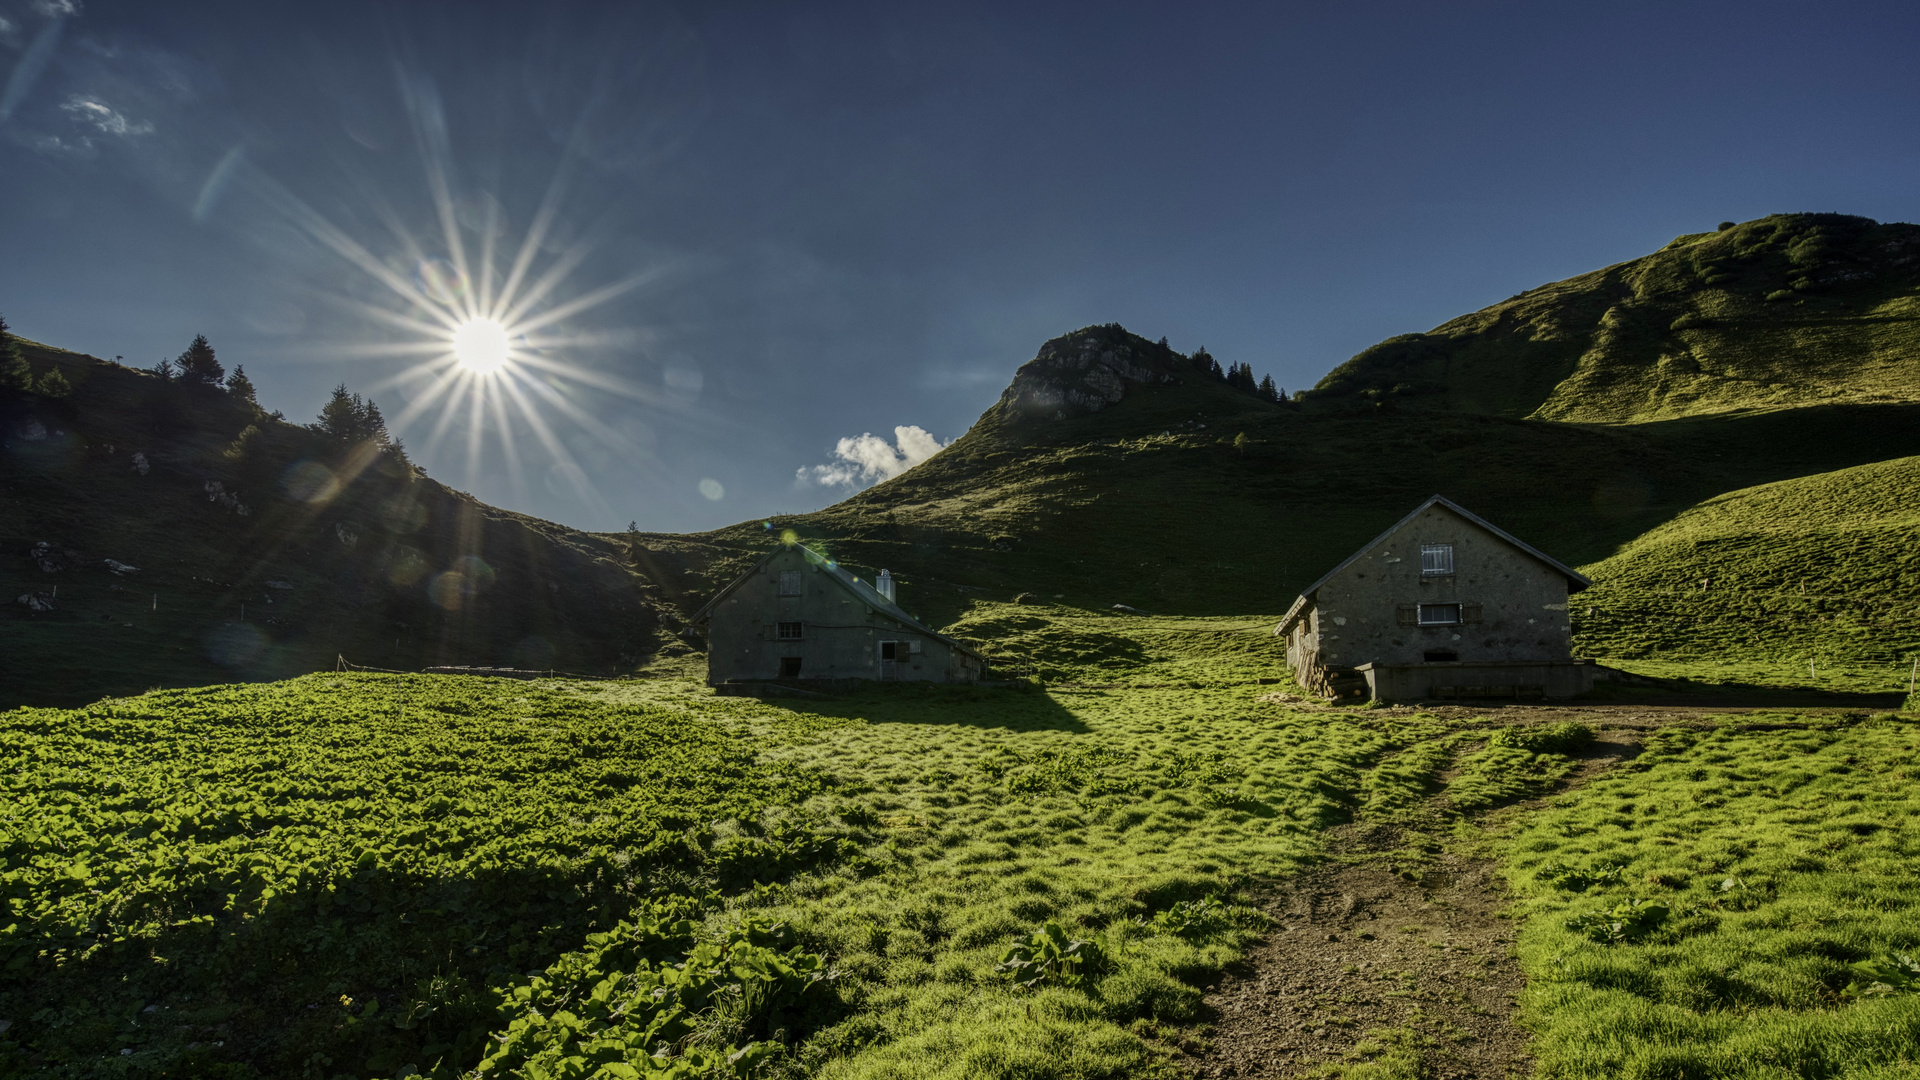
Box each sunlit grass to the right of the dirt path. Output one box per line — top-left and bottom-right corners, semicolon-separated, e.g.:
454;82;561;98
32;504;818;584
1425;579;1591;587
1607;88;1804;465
1505;715;1920;1078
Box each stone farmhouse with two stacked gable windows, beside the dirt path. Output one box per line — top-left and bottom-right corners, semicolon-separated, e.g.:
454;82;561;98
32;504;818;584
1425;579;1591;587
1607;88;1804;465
1273;496;1596;701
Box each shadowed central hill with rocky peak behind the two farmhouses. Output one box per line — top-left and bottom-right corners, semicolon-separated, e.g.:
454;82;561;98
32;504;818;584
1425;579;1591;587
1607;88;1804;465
643;319;1920;638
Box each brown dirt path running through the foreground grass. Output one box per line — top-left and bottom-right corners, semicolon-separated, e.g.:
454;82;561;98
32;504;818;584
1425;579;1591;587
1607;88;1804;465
1183;717;1643;1080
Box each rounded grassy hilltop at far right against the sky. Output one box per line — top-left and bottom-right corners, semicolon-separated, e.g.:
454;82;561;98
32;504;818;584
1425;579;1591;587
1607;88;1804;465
1308;213;1920;423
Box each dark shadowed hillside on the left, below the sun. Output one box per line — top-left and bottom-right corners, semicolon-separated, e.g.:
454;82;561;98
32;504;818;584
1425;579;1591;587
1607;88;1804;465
0;342;670;705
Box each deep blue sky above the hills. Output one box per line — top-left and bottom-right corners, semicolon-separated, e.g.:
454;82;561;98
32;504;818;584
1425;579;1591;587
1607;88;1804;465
0;0;1920;530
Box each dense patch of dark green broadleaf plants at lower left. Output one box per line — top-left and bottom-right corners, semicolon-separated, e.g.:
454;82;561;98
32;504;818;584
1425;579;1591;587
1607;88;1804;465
0;675;858;1078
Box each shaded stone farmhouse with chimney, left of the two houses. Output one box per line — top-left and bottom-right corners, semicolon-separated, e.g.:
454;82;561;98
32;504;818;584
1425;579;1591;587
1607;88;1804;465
693;544;987;688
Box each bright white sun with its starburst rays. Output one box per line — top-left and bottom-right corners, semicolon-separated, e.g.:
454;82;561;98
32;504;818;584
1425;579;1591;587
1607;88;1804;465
238;79;689;521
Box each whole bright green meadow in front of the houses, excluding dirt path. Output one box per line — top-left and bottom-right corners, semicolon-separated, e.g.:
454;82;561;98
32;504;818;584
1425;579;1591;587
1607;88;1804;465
0;605;1920;1080
